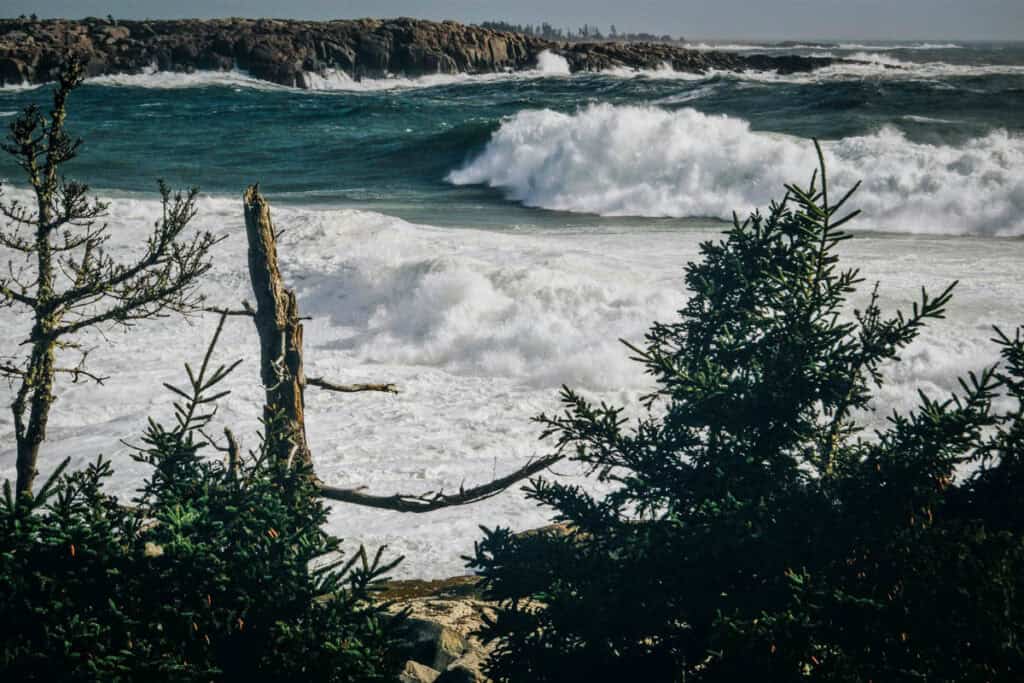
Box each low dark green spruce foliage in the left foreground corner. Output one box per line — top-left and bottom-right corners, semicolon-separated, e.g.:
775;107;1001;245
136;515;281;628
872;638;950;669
0;321;397;682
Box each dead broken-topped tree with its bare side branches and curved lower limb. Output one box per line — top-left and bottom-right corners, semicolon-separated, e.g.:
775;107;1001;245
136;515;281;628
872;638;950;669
235;185;562;512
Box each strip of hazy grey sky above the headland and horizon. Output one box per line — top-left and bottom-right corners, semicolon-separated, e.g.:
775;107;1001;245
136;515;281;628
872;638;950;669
8;0;1024;40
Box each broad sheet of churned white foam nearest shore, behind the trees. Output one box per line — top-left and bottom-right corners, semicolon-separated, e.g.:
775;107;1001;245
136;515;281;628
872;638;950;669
0;187;1024;578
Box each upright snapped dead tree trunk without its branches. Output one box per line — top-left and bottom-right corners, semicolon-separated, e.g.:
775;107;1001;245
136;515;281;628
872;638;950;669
243;185;312;465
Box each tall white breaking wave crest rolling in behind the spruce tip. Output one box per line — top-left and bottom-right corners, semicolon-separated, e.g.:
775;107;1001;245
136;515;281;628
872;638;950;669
449;104;1024;236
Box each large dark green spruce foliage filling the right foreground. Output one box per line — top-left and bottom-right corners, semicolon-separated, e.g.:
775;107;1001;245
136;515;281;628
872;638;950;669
470;147;1024;682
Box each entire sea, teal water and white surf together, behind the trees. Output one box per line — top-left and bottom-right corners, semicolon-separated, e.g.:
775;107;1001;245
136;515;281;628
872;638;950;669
0;42;1024;578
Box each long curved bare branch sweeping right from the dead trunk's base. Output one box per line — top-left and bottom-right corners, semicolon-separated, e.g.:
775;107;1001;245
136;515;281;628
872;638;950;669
319;453;563;513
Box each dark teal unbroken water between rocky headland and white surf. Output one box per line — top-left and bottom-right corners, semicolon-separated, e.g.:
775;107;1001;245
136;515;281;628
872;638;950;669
0;44;1024;229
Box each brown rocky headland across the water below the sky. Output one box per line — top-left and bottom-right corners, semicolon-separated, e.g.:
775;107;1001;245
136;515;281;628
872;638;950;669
0;18;836;88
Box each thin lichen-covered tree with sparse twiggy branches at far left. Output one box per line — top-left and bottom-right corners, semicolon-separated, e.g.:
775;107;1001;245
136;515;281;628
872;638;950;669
0;60;217;497
